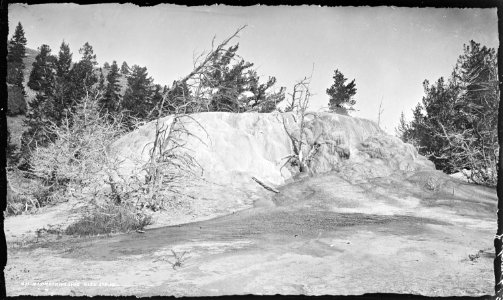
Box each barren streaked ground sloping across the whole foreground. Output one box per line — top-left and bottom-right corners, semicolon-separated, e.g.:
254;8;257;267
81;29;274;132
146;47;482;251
6;173;496;296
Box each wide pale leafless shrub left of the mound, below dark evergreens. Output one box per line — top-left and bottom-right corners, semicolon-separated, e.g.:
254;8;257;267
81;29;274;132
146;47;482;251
30;94;124;203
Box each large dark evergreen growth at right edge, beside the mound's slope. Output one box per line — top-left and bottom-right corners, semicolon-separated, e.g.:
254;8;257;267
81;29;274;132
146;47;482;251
403;41;499;184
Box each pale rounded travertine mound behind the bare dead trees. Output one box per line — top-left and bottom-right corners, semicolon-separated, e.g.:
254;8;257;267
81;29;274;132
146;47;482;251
110;112;432;189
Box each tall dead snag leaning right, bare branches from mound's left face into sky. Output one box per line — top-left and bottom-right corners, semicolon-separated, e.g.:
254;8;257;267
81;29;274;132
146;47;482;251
133;26;246;208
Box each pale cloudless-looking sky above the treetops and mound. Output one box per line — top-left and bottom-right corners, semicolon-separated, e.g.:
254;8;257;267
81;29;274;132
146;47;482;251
9;4;498;133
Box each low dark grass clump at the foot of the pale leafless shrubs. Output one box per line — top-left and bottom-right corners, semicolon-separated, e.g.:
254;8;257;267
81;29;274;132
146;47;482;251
65;204;153;235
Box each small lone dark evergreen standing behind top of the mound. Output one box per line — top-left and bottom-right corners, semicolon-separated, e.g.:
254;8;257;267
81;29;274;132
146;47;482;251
327;69;356;115
